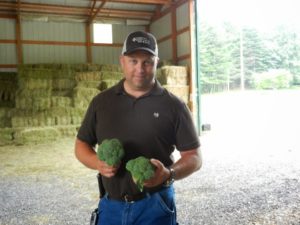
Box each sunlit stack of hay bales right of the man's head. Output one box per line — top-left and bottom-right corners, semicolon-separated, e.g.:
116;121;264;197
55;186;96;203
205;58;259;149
156;66;189;104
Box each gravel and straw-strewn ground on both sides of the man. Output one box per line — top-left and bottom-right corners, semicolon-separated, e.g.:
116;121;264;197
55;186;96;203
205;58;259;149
0;91;300;225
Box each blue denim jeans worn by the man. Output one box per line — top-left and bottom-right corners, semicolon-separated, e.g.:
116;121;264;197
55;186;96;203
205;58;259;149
98;187;177;225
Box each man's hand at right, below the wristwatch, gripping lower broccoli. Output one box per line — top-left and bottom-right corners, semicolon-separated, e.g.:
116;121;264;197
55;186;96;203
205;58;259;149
144;159;170;187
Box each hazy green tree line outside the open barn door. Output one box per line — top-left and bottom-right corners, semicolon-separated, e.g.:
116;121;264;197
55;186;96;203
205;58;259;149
198;22;300;93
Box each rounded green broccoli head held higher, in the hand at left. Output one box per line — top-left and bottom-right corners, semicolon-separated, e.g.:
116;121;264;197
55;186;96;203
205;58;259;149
97;138;125;166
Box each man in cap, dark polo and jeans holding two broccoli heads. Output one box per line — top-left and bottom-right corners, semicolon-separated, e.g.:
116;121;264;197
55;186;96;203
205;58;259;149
75;31;202;225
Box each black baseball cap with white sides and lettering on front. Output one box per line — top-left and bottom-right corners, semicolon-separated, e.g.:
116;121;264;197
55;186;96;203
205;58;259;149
122;31;158;56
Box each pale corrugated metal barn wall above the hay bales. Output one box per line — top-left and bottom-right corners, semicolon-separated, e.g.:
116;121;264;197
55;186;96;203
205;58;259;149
0;3;190;65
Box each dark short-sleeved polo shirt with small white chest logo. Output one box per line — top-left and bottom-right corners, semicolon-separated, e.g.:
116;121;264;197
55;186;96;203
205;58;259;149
77;80;200;197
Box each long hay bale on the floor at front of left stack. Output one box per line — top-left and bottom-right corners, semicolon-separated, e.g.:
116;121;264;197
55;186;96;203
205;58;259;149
14;127;61;145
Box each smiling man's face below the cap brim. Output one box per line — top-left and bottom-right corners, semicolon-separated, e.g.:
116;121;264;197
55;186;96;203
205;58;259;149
120;51;158;91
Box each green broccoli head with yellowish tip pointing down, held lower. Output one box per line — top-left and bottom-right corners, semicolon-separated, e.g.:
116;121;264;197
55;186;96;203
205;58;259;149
126;156;155;192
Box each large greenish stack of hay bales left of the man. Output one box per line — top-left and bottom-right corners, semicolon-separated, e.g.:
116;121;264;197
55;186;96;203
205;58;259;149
0;64;127;146
